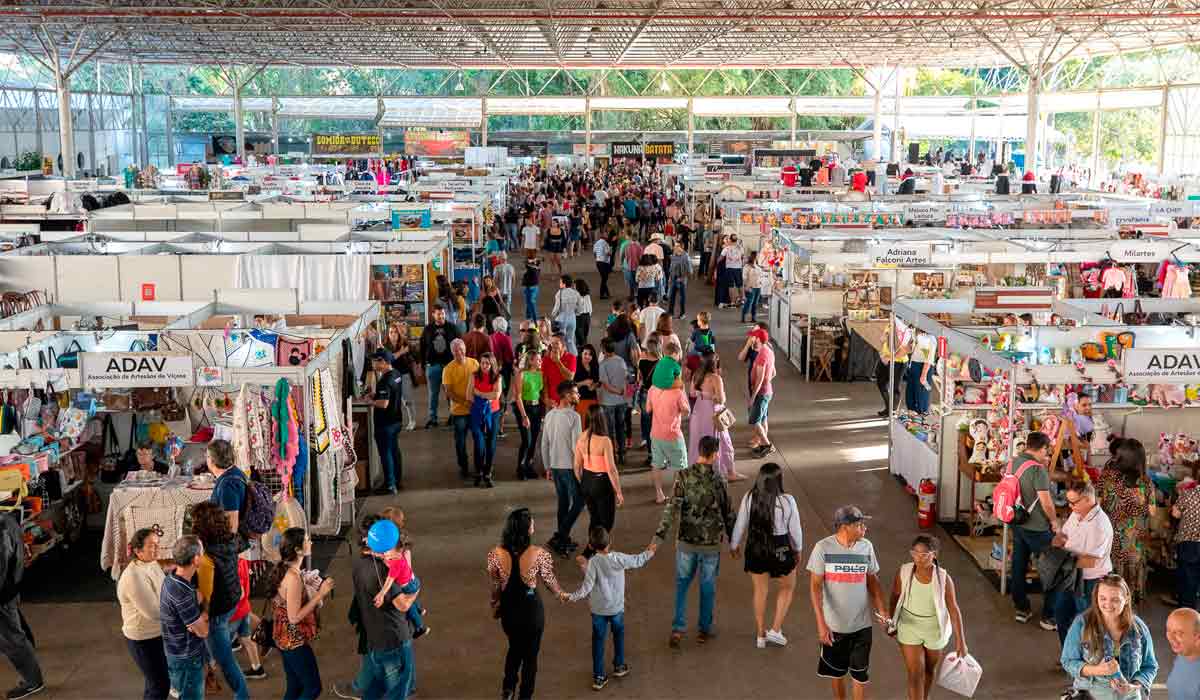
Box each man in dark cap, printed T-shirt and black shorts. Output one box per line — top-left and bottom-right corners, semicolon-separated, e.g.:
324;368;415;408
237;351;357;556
809;505;887;700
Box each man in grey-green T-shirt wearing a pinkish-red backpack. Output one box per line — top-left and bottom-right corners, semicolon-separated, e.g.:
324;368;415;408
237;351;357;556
1010;432;1058;632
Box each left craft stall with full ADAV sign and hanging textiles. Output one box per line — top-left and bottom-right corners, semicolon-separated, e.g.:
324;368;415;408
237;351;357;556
0;289;379;580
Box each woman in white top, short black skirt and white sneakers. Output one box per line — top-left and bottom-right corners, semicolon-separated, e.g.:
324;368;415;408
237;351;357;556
730;462;804;648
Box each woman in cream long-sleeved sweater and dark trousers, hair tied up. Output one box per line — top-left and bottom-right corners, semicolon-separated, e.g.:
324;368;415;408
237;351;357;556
116;526;170;700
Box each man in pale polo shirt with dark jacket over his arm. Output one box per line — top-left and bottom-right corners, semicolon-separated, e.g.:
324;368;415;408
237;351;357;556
1052;480;1112;645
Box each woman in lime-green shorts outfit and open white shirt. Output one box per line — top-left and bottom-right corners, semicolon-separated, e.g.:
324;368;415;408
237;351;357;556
888;534;967;700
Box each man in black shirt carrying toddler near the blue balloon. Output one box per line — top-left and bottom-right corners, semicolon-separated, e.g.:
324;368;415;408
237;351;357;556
353;551;416;700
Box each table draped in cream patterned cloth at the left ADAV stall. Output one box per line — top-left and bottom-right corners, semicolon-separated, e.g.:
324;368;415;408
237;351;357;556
100;478;212;581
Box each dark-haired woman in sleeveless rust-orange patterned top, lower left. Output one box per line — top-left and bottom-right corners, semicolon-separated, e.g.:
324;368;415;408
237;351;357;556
266;527;334;700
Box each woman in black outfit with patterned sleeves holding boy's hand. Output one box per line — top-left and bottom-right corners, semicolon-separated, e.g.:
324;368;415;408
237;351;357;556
487;508;564;700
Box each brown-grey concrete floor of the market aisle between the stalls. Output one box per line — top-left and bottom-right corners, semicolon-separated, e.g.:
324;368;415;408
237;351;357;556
0;257;1170;700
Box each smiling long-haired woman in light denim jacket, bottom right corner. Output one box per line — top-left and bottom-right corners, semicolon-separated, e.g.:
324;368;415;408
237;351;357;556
1060;574;1158;700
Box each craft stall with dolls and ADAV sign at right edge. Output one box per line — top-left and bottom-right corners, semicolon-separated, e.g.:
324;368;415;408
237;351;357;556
889;290;1200;592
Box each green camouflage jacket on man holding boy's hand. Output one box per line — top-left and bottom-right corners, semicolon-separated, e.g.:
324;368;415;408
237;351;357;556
654;463;733;551
